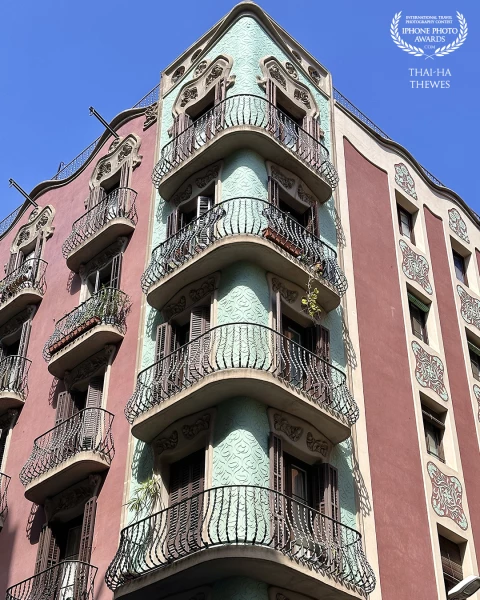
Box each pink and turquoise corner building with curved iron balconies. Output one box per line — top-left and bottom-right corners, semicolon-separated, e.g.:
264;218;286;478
0;3;480;600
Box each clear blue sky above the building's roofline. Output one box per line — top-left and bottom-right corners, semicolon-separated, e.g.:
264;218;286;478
0;0;480;219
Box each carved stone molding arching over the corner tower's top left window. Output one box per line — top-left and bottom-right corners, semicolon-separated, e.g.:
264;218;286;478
173;54;235;116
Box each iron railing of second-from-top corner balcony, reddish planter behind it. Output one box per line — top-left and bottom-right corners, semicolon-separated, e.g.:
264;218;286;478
141;198;348;296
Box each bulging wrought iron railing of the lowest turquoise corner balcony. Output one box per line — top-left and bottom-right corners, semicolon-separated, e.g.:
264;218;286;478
105;485;375;594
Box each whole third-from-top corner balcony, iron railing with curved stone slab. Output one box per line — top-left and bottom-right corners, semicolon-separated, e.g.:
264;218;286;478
125;323;358;444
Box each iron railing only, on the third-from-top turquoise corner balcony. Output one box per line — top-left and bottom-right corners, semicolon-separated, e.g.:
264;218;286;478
125;323;359;424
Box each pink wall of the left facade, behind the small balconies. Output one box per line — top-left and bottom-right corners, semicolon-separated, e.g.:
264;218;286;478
0;115;156;600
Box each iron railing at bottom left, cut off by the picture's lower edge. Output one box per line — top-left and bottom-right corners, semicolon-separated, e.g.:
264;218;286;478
6;560;97;600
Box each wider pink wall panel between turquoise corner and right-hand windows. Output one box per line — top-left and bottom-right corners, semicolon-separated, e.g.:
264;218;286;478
344;140;437;600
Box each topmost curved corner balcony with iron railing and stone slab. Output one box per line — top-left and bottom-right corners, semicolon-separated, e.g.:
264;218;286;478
152;95;338;202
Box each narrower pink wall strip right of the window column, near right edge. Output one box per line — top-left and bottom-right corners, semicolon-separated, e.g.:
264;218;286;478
425;207;480;560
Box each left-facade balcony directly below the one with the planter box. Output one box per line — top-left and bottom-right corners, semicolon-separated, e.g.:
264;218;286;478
20;408;115;504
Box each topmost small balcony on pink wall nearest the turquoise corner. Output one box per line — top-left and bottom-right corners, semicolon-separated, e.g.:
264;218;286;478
62;188;138;272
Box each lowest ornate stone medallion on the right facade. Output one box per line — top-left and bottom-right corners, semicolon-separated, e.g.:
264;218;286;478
427;462;468;531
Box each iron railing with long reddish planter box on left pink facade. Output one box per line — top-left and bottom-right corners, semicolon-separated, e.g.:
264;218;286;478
43;288;130;361
